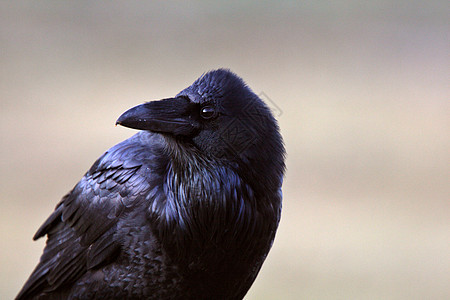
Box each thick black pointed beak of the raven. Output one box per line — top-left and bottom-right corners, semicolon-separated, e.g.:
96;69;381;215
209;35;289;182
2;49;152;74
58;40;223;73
116;98;198;136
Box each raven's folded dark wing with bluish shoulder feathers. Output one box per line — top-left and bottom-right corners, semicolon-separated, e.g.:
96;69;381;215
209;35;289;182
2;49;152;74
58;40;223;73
17;141;155;299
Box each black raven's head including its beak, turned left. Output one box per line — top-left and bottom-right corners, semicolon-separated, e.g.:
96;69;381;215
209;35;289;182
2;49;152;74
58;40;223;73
117;69;284;192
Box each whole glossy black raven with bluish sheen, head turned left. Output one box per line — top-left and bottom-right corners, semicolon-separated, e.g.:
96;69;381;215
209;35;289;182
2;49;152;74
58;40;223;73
17;69;285;299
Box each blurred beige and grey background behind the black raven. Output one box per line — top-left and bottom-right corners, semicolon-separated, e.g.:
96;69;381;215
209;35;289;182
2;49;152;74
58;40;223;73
0;0;450;299
